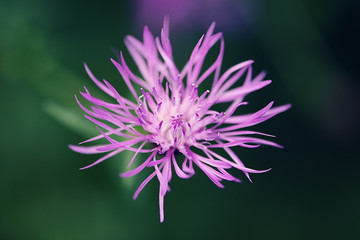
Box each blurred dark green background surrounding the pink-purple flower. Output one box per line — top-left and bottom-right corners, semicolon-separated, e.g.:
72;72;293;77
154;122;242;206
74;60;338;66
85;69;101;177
0;0;360;240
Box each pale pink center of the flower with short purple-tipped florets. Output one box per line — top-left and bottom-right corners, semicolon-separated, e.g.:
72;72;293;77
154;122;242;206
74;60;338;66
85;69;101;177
136;86;223;153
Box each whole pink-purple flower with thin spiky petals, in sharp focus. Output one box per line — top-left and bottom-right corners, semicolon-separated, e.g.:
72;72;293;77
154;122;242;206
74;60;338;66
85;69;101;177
70;18;290;222
